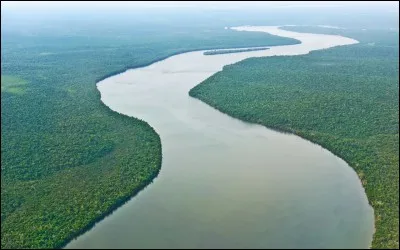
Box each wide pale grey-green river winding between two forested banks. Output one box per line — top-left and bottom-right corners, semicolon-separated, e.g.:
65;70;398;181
66;26;374;248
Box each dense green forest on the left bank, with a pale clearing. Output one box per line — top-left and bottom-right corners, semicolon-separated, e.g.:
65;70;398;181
1;5;298;248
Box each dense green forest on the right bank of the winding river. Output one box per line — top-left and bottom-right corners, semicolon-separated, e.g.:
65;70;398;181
189;27;399;249
